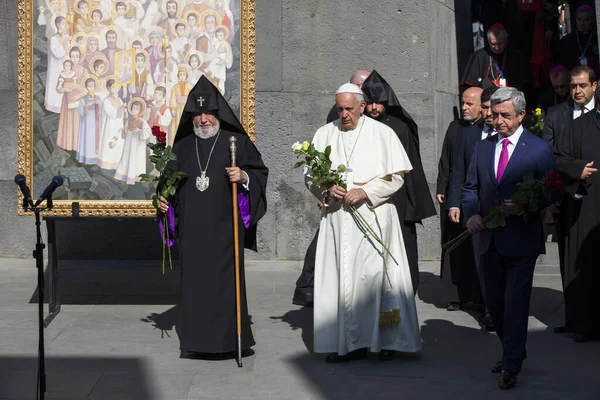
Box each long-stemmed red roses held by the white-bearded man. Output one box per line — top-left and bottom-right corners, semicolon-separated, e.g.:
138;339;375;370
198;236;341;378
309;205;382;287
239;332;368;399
140;126;185;274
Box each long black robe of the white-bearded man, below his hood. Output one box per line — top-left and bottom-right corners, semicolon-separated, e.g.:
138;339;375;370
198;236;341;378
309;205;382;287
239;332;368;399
173;130;268;353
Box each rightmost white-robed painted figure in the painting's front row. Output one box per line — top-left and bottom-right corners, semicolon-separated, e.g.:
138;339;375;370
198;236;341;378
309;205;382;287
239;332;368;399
115;97;152;185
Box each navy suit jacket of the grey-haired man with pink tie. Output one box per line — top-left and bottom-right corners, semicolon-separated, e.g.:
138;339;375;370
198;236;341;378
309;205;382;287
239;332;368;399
462;129;555;257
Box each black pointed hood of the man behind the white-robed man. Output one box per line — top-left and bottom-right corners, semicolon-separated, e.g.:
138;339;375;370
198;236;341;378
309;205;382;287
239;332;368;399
362;70;419;143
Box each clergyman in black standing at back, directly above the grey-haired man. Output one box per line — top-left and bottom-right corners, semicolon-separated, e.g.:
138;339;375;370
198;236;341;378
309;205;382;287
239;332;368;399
460;24;531;90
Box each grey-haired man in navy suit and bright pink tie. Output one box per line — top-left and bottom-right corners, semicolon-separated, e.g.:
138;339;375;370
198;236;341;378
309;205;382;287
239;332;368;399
462;87;554;389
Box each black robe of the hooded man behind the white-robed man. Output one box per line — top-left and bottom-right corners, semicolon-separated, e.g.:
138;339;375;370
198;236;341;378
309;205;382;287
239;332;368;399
379;114;436;293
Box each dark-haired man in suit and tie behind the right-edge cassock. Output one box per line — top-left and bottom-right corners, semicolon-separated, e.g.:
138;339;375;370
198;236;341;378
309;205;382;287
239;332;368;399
542;66;597;333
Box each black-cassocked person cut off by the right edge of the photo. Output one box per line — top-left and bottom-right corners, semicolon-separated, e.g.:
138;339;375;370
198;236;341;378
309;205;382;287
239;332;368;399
554;89;600;342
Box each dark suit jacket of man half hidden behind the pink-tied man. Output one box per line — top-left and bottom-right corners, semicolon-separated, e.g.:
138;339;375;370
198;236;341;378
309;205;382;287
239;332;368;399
446;122;483;209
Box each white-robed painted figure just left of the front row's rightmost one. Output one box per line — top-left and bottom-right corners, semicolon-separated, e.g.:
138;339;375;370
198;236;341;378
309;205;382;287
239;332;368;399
98;79;125;170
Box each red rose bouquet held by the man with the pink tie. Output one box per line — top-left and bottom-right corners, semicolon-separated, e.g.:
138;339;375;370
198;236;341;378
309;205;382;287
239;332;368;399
442;171;565;256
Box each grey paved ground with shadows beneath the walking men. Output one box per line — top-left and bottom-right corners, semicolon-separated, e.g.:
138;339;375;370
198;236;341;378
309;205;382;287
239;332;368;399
0;242;600;400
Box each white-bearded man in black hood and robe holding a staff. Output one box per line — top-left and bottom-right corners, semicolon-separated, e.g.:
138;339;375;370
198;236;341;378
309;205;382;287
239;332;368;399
160;76;268;359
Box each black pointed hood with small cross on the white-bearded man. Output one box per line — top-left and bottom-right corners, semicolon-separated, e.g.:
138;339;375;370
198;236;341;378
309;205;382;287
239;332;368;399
175;75;248;143
